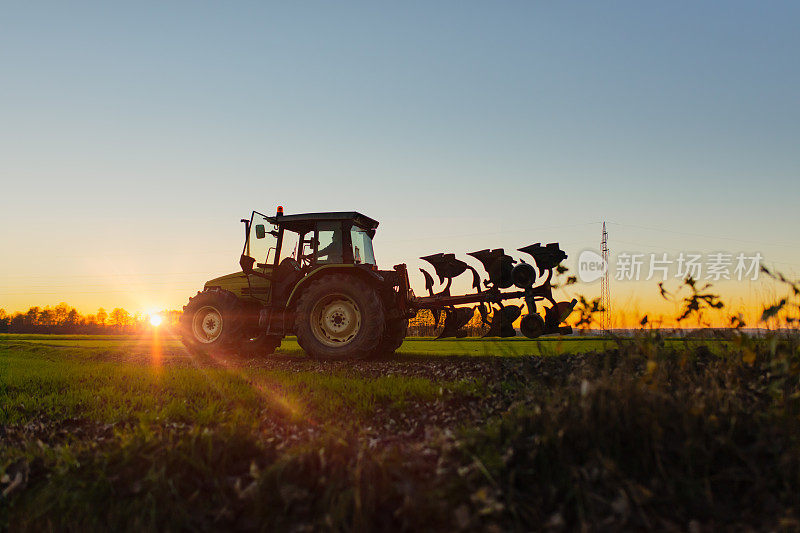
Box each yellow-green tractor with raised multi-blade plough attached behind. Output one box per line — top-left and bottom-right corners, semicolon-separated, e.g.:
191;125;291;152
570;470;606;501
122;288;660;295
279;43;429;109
179;207;576;359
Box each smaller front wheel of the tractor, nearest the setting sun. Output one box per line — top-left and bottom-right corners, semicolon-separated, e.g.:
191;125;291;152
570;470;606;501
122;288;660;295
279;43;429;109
179;288;241;355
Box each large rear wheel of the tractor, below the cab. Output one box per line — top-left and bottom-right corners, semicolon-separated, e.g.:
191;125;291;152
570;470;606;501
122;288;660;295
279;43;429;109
294;274;385;359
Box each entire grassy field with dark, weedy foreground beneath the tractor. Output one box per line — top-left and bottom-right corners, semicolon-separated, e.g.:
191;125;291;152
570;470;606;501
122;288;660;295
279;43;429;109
0;333;800;531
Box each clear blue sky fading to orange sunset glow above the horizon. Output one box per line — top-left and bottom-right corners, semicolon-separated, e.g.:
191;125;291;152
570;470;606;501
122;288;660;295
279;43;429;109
0;1;800;324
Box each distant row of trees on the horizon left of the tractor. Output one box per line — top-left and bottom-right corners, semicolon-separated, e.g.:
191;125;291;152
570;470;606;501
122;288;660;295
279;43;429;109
0;302;180;334
